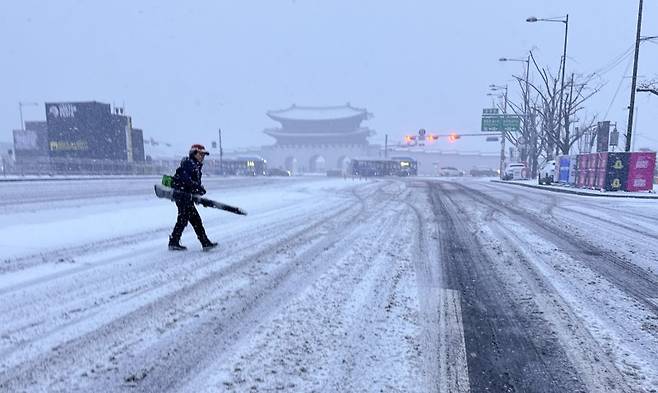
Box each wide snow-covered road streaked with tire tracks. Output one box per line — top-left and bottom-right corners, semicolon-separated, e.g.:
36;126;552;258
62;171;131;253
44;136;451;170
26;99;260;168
0;177;658;392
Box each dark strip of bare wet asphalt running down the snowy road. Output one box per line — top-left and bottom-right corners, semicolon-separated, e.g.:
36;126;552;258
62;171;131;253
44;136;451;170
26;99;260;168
430;182;584;392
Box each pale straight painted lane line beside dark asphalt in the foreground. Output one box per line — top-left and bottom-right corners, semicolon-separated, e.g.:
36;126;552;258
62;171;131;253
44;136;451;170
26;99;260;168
438;289;470;392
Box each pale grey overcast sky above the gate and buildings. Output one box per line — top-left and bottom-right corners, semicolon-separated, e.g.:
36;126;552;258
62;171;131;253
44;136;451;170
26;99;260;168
0;0;658;151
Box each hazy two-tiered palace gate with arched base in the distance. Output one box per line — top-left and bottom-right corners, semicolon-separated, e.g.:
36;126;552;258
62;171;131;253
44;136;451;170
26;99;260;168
262;103;380;173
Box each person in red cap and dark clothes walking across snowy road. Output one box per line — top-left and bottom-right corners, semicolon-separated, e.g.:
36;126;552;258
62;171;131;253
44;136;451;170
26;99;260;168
169;144;217;251
